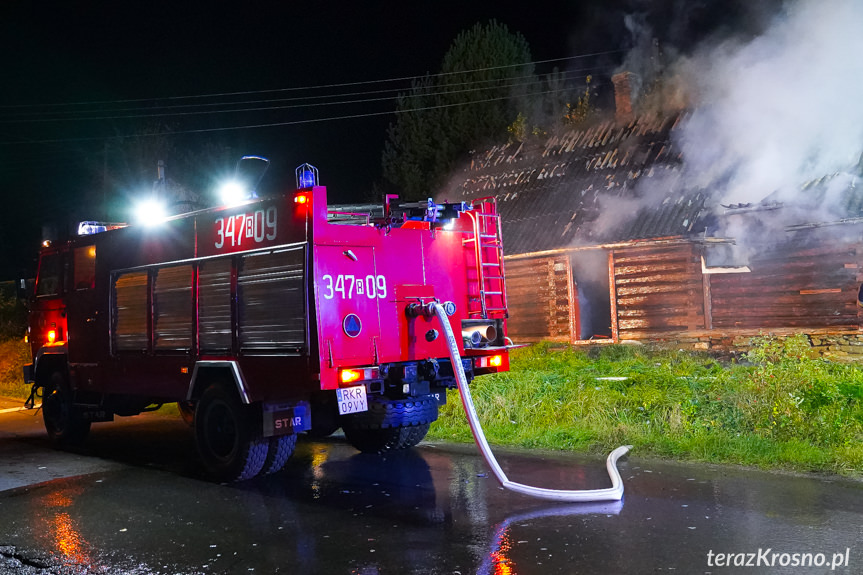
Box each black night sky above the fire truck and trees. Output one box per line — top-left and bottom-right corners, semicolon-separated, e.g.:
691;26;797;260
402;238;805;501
0;0;780;281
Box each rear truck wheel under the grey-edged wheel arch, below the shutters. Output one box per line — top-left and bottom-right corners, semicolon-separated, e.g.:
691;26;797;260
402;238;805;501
195;384;270;482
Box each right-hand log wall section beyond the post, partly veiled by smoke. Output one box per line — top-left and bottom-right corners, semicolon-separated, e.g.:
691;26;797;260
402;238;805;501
710;241;861;329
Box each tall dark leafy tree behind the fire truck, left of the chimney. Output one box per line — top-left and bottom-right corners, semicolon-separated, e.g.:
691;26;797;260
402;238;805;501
382;20;535;199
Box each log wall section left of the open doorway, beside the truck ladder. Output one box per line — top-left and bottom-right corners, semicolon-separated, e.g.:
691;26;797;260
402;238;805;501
506;255;571;343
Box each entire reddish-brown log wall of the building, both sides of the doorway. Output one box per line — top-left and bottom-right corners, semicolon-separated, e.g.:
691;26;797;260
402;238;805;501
506;232;863;348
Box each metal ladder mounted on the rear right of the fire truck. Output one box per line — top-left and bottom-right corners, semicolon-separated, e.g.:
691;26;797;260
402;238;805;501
463;197;508;319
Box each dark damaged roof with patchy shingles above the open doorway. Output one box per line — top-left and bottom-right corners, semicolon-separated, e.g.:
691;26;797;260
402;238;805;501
440;113;706;255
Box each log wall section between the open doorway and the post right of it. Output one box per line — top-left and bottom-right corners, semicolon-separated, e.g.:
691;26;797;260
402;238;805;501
613;244;706;339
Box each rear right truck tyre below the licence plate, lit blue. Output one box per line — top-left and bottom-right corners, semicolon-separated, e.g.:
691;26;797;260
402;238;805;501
342;395;438;453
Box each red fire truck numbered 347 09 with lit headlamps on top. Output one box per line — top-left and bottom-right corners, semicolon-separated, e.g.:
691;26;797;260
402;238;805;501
24;165;509;481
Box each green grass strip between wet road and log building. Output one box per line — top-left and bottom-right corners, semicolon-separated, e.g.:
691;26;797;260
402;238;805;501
429;336;863;477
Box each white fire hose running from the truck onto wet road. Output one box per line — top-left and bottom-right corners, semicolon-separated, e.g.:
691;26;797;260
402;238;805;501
436;303;632;502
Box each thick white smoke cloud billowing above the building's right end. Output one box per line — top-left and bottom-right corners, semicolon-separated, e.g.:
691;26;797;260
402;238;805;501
677;0;863;212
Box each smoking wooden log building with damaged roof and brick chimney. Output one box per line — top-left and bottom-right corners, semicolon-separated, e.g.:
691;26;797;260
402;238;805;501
444;77;863;354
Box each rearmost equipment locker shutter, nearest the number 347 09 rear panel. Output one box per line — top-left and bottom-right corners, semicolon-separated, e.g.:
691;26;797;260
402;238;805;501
237;247;306;351
